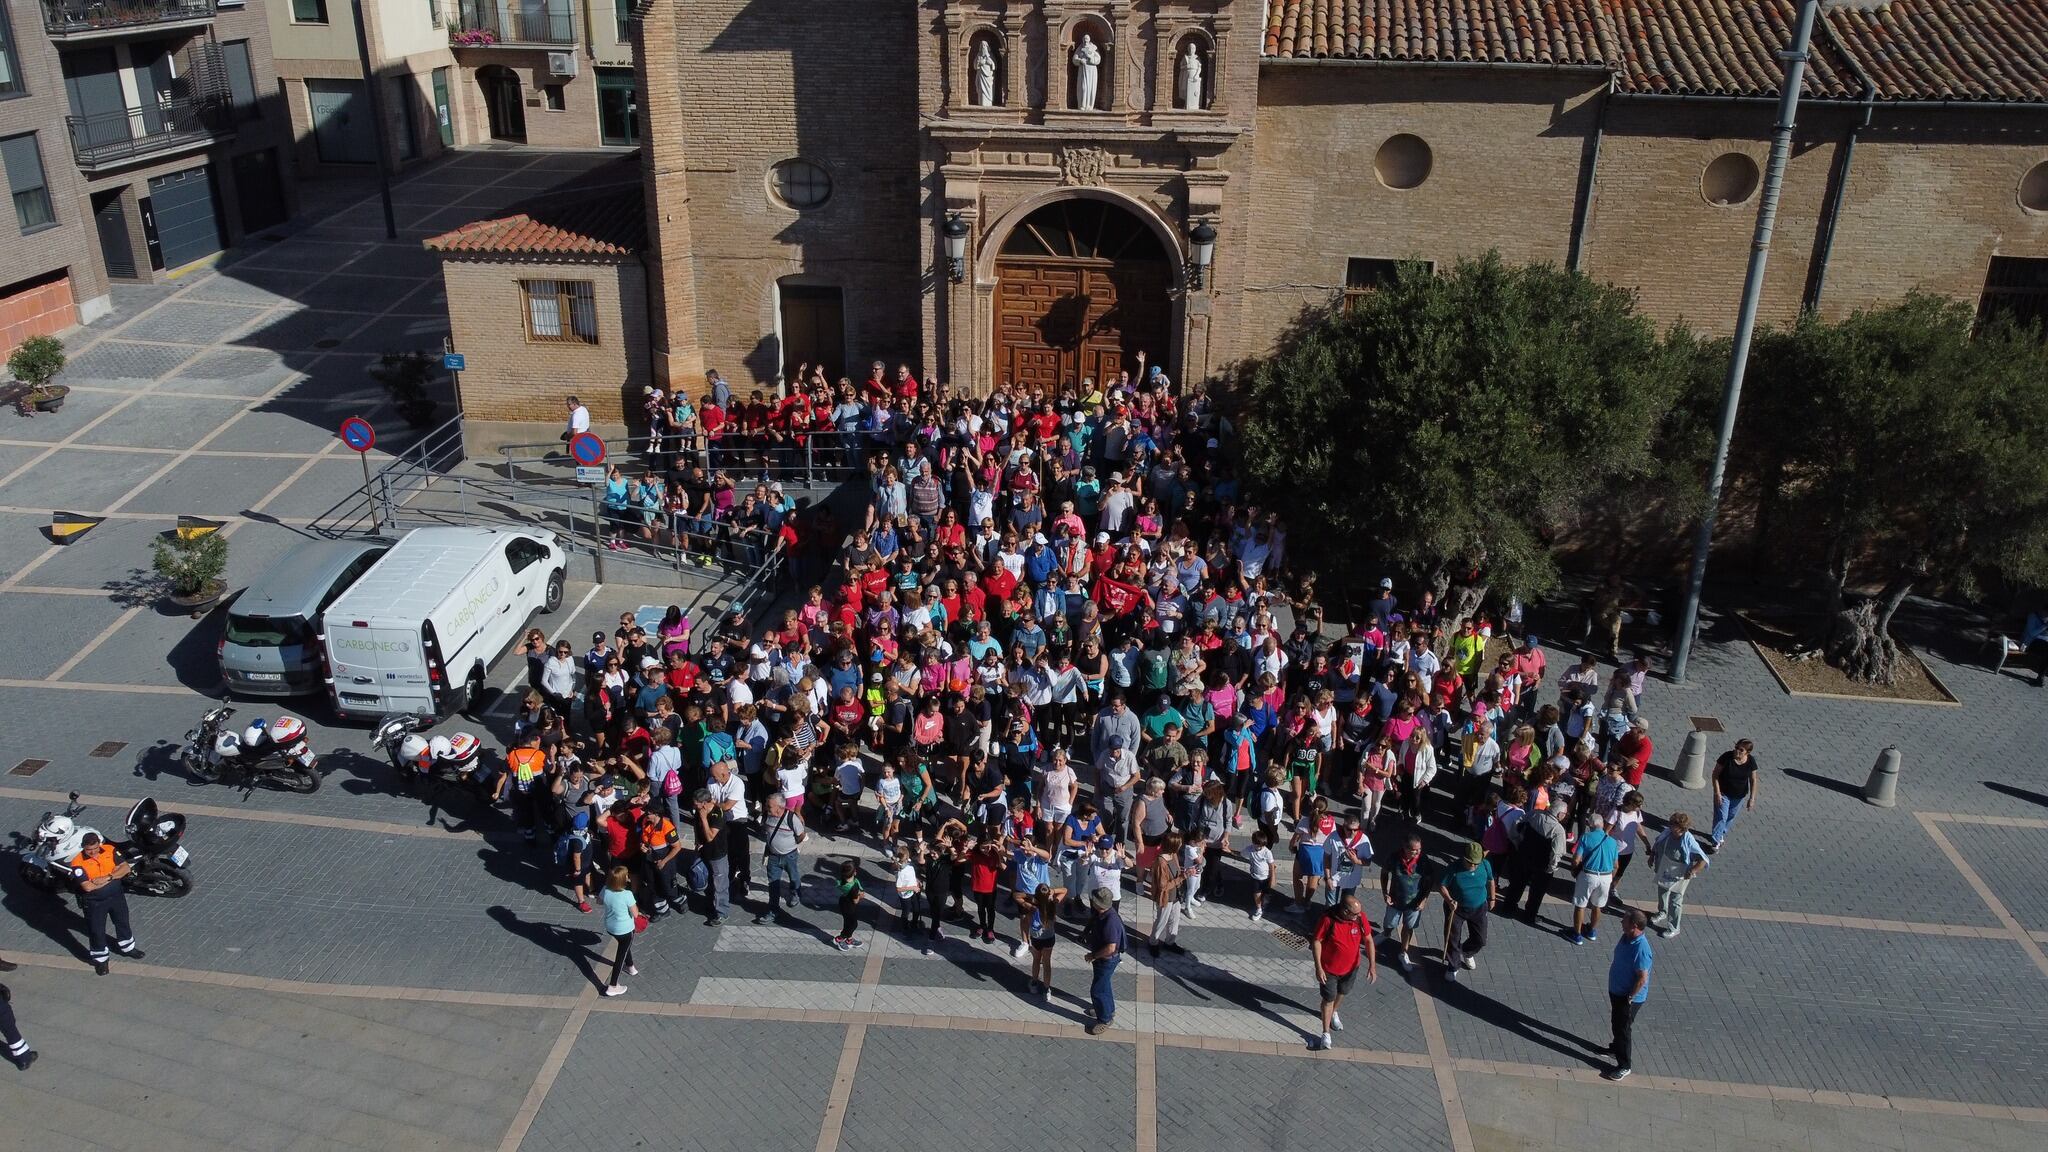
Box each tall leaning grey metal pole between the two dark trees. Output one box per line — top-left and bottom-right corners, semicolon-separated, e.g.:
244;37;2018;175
1671;0;1821;685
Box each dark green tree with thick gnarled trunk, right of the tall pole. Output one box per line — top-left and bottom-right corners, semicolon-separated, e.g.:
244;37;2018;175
1737;295;2048;681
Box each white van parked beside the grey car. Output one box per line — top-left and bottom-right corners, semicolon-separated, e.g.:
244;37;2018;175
319;529;567;717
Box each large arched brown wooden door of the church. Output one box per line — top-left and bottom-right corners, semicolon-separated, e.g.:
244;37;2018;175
995;199;1174;389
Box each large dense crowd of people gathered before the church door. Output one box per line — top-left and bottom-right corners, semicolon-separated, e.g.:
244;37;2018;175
498;359;1755;1074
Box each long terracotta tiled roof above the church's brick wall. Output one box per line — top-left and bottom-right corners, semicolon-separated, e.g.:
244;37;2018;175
1266;0;2048;100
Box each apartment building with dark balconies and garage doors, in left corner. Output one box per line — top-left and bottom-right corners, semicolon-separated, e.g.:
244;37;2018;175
0;0;295;355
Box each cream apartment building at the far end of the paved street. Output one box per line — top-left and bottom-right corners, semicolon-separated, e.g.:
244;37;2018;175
268;0;639;176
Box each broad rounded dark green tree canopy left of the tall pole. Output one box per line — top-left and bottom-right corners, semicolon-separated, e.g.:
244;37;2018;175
1243;254;1710;599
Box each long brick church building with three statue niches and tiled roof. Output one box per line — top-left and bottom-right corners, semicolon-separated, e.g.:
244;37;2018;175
451;0;2048;418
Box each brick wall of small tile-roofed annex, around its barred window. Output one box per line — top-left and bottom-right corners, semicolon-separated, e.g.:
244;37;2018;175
440;258;651;424
